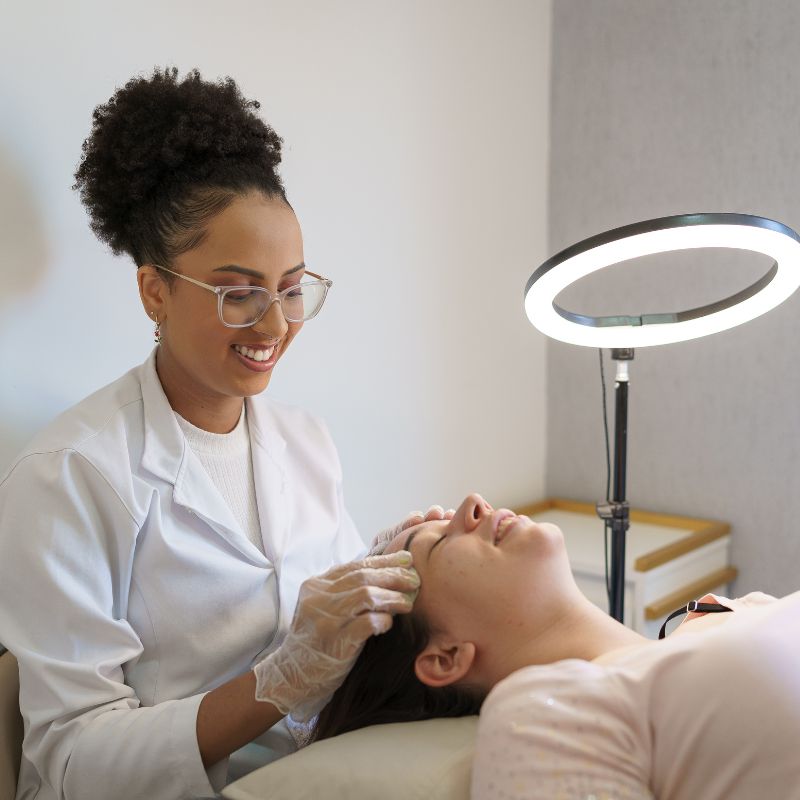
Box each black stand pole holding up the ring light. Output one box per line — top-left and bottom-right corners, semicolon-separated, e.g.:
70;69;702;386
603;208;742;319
597;348;633;622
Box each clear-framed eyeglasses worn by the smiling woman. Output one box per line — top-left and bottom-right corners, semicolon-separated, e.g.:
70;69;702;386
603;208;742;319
152;264;333;328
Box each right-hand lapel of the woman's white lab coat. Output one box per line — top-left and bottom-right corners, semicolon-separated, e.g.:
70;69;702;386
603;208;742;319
245;398;292;577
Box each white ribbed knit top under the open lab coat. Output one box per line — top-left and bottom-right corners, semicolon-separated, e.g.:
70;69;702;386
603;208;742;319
175;405;264;553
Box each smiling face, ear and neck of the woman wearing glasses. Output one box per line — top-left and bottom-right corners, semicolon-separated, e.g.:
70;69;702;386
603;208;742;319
139;192;304;432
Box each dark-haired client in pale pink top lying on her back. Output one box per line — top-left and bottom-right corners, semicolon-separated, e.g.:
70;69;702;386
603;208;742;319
316;495;800;800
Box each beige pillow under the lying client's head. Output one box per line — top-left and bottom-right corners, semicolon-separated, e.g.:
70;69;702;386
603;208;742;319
222;716;478;800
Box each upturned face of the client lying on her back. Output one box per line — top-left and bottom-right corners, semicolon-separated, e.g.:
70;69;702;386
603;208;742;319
386;494;577;684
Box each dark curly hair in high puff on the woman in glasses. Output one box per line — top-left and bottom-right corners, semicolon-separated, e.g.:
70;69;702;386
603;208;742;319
72;67;288;266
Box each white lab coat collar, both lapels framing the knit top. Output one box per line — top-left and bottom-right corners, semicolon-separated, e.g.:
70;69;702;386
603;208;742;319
139;347;289;569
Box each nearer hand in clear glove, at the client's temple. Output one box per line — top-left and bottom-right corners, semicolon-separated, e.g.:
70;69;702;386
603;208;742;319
253;550;419;722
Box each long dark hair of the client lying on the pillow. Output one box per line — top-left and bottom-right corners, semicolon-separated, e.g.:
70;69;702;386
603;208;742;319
313;612;485;740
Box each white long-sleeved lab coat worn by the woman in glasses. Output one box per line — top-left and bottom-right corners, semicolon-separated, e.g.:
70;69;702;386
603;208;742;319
0;350;364;800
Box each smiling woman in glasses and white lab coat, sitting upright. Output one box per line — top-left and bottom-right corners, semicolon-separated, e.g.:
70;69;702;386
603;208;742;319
0;69;442;800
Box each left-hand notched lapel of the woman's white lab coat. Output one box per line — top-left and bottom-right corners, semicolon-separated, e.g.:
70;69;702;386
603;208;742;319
140;348;265;564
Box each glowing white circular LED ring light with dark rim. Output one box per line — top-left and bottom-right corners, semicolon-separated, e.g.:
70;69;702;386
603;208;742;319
525;214;800;348
